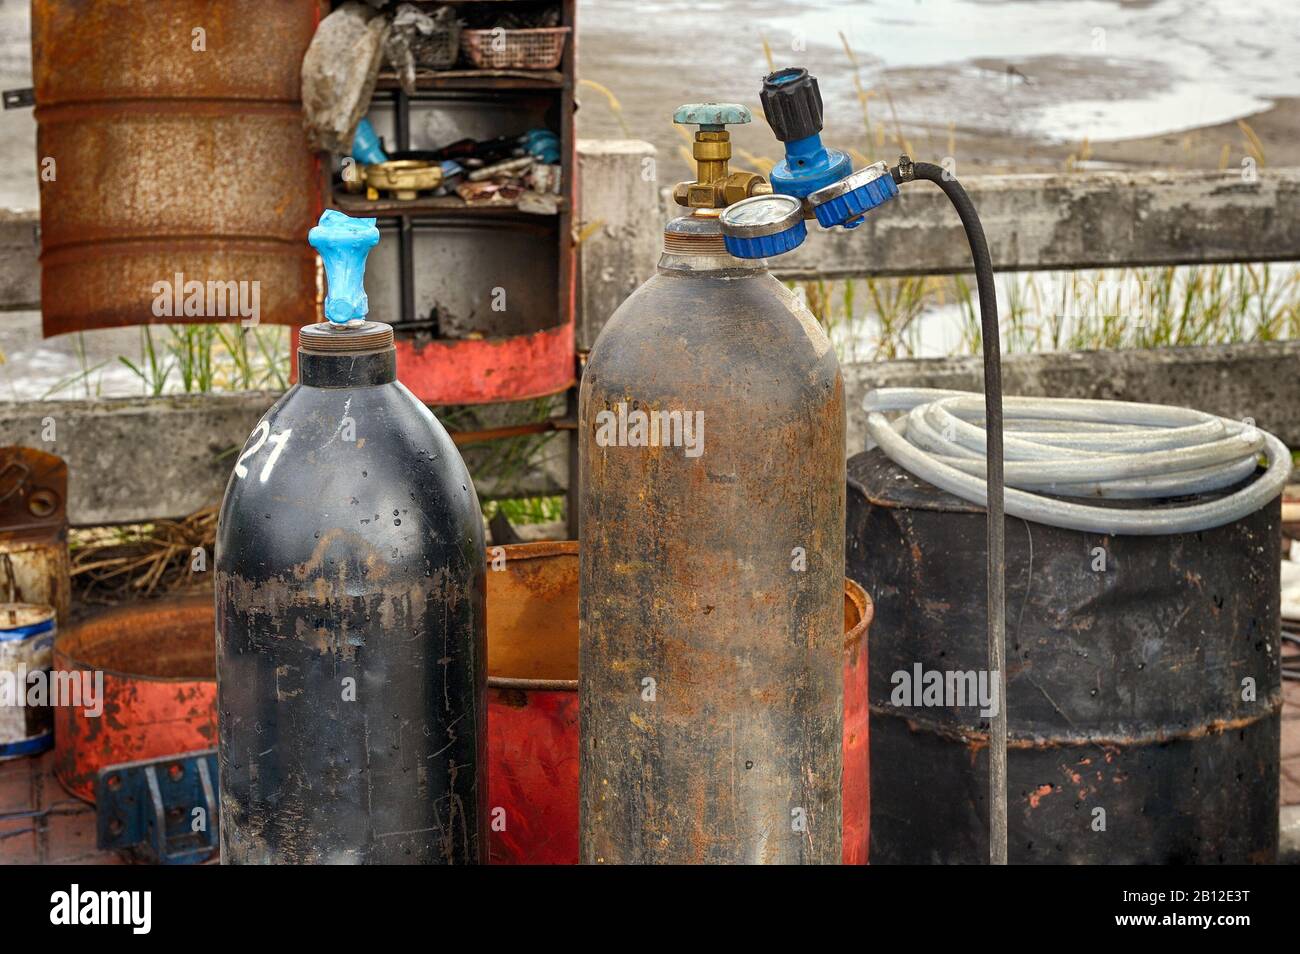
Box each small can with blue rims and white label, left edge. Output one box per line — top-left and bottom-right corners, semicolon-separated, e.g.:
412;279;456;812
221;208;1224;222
0;603;55;760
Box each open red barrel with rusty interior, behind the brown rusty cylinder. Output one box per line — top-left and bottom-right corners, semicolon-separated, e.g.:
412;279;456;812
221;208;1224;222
488;541;872;864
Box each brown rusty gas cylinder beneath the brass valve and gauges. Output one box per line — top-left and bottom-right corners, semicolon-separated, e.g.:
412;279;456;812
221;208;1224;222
580;200;845;864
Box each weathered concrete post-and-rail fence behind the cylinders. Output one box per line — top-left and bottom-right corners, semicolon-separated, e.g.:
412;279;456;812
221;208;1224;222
0;140;1300;525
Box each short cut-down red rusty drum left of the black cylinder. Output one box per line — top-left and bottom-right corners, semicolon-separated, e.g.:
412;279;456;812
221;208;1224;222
55;594;217;801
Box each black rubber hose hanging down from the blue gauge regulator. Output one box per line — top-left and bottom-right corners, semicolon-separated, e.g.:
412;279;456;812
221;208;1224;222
889;156;1008;864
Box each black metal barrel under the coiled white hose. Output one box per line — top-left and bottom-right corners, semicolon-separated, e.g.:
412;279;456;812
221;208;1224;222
848;450;1282;864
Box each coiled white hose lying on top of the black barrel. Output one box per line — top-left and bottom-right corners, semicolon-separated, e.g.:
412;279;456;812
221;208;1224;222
863;387;1291;535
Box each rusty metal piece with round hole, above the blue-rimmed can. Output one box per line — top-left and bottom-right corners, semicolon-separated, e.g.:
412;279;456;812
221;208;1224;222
0;447;72;623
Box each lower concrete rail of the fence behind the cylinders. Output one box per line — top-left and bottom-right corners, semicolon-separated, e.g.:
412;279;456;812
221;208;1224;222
0;342;1300;525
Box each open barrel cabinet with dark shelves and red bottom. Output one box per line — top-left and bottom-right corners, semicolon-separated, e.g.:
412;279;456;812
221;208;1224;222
314;0;577;535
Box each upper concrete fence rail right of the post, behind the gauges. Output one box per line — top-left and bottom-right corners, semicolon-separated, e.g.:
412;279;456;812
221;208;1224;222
772;169;1300;278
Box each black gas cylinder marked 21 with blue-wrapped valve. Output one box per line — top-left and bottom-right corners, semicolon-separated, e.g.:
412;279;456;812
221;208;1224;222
216;212;488;864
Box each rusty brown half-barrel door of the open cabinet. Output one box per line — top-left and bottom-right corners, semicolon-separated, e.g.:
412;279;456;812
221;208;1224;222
33;0;321;335
